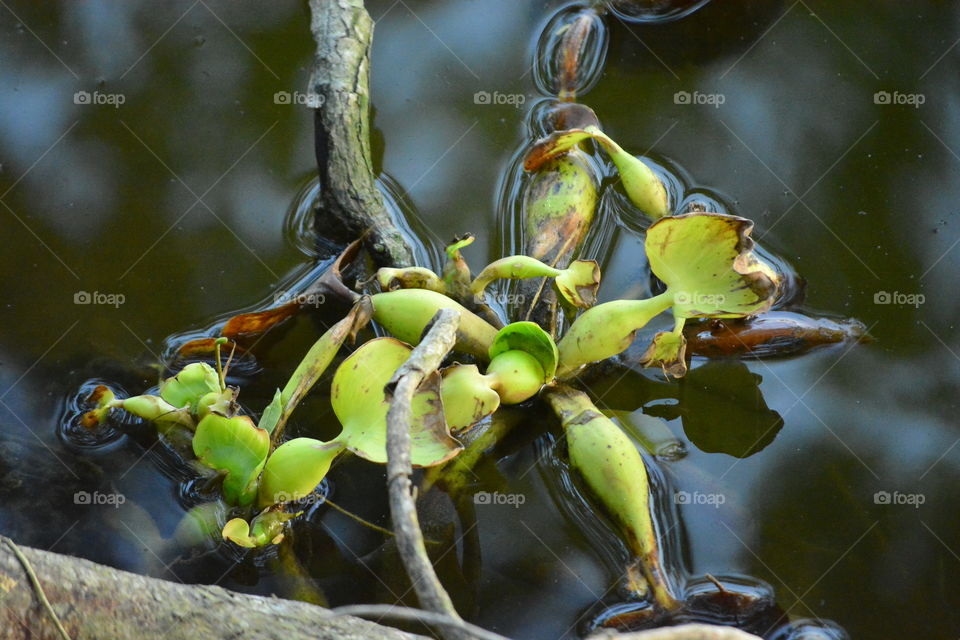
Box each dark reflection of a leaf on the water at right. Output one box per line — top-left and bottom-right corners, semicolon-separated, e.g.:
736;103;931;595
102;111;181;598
678;362;783;458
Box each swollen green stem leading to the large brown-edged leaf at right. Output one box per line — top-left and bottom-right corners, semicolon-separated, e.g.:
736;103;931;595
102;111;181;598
557;290;674;380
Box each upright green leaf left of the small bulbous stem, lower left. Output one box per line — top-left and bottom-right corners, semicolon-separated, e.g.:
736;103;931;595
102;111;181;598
193;413;270;506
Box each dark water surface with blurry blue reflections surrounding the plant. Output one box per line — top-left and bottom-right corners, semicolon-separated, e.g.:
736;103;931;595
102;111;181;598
0;0;960;638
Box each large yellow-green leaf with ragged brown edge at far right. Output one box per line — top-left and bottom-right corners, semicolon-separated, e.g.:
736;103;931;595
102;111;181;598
645;213;780;318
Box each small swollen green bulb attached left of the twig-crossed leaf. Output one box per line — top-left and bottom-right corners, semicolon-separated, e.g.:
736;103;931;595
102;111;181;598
258;438;343;507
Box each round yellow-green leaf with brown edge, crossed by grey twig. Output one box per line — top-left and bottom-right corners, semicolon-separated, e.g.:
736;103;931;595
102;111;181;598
330;338;462;467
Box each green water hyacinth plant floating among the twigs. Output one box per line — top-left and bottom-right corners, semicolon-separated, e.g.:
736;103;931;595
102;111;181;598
85;204;778;568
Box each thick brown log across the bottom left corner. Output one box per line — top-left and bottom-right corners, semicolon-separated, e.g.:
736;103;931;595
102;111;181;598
0;544;423;640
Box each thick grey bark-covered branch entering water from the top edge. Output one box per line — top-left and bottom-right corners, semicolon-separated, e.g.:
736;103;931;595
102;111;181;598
308;0;413;267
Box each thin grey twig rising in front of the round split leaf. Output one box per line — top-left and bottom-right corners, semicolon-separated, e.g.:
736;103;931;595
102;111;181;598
386;309;464;638
